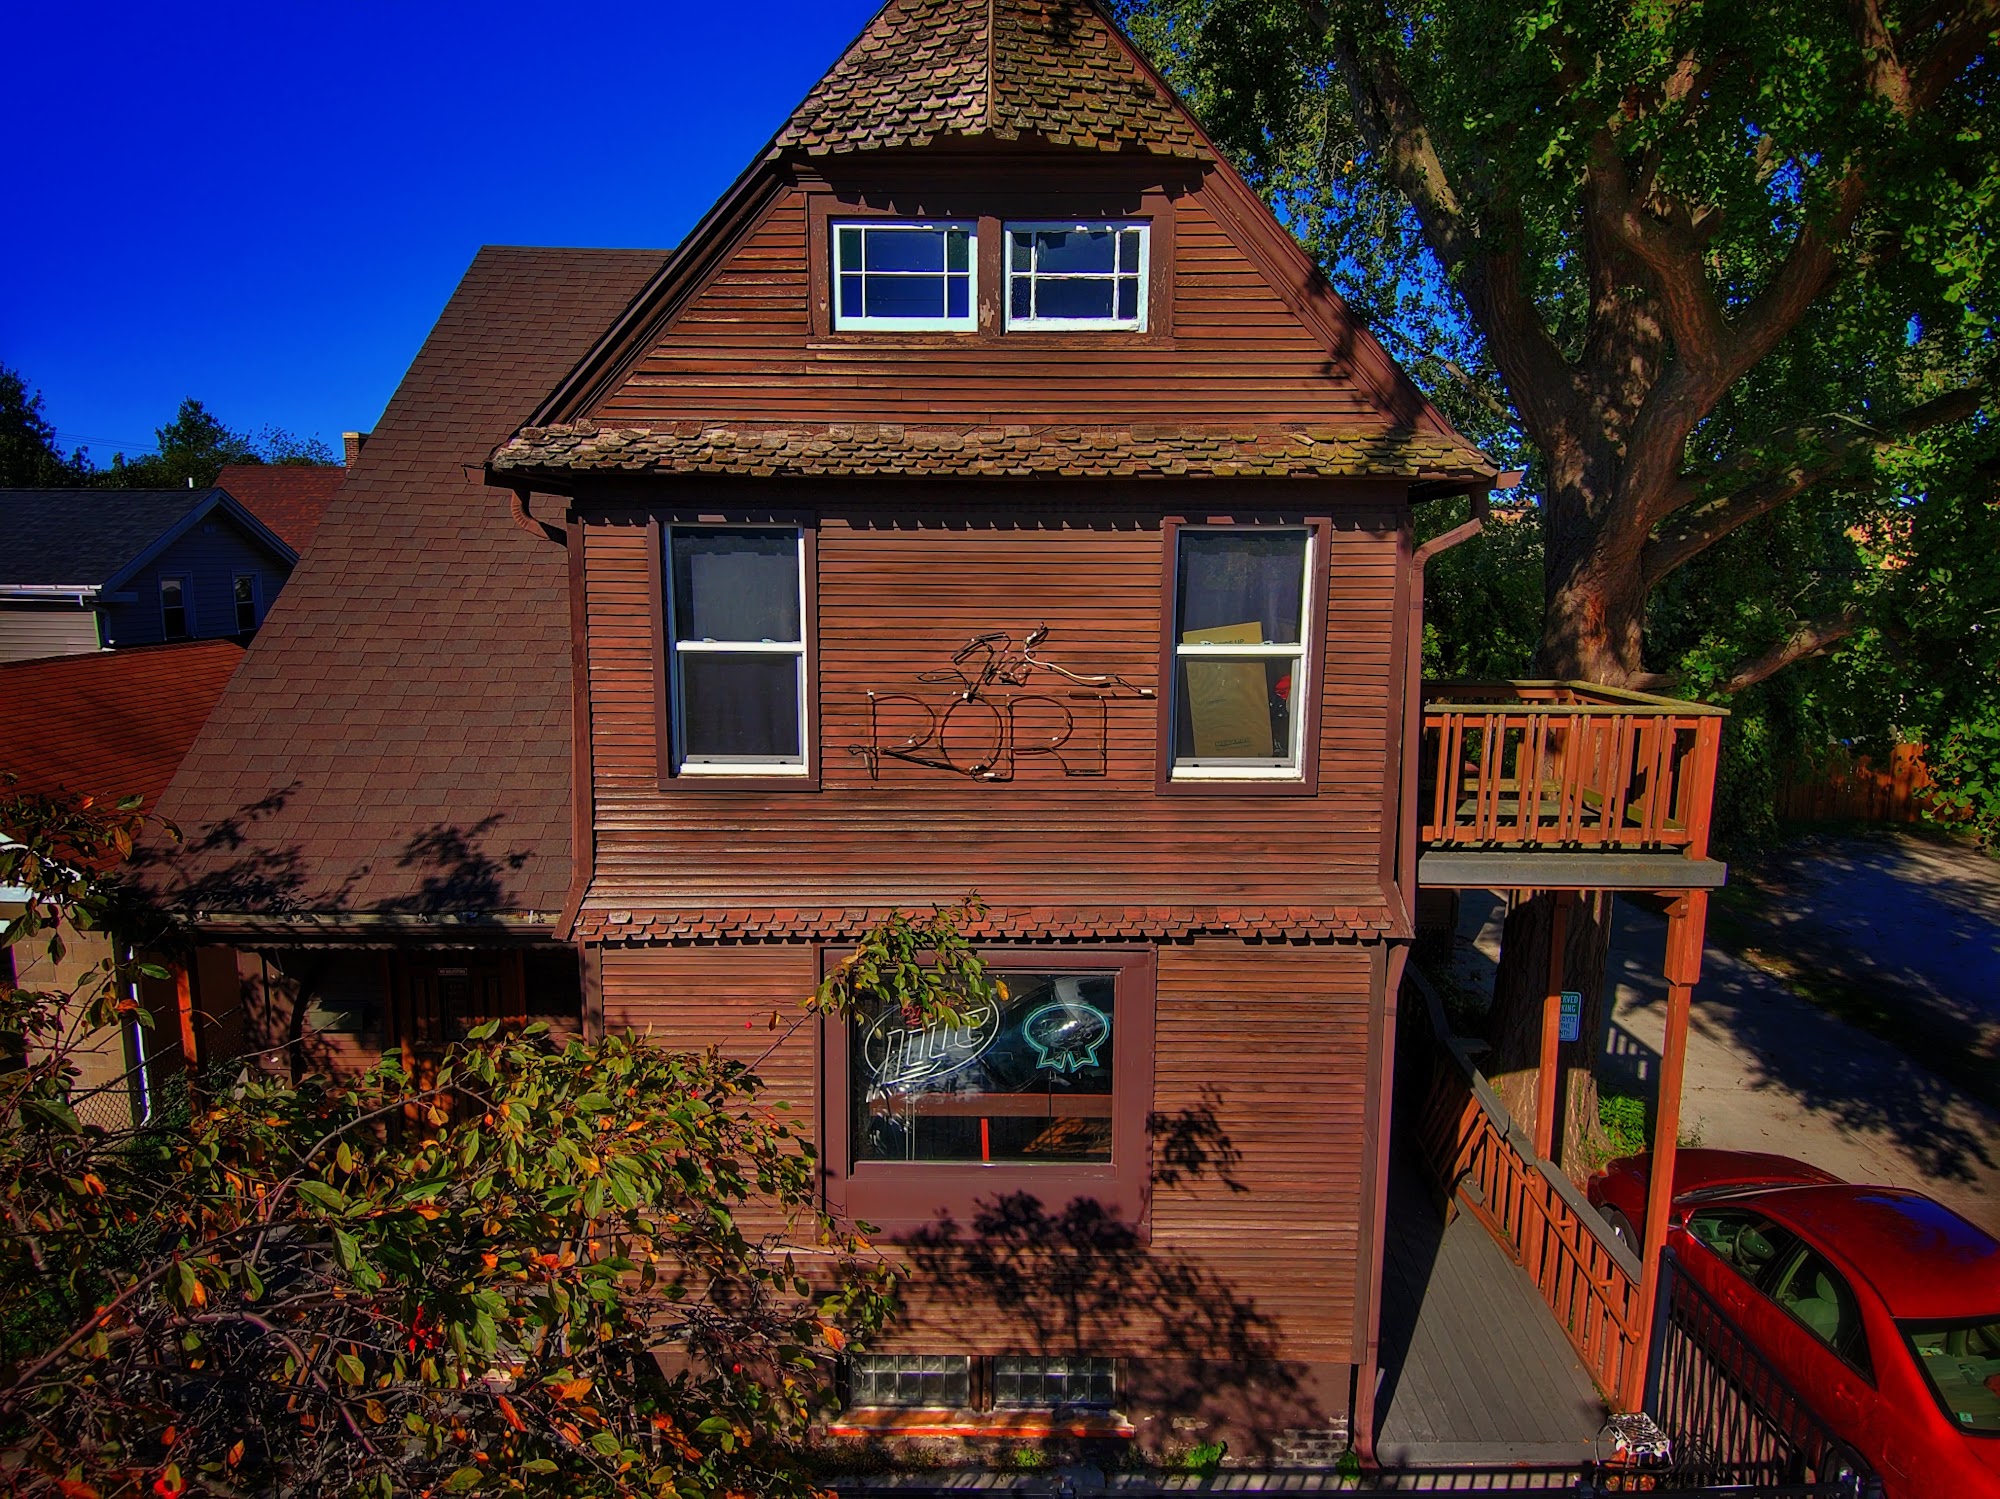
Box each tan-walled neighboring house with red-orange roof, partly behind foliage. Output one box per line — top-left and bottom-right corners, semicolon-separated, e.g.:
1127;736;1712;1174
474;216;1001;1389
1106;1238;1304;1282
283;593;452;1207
0;640;244;1125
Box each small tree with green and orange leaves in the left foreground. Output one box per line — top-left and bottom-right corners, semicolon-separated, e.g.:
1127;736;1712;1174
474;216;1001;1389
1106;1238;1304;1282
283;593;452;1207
0;797;986;1499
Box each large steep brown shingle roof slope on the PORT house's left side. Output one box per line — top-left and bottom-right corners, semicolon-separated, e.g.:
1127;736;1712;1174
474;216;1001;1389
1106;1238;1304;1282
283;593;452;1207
156;248;664;913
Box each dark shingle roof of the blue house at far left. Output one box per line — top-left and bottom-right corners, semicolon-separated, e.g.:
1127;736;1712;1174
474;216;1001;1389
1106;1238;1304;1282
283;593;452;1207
0;490;214;588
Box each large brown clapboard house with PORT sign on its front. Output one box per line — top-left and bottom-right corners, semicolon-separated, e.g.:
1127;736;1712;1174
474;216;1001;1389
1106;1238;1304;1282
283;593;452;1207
152;0;1720;1453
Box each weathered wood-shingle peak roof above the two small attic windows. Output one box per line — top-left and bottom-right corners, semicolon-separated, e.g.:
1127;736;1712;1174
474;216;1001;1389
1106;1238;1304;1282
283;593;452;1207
770;0;1214;160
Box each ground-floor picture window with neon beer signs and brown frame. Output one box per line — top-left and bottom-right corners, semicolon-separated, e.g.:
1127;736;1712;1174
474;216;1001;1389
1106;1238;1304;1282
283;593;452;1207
822;947;1154;1231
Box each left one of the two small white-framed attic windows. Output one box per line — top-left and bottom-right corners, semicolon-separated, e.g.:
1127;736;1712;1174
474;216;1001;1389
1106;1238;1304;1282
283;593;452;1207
834;220;980;334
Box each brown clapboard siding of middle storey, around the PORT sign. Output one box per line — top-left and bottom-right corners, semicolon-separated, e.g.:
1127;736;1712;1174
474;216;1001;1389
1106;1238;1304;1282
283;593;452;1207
586;499;1402;909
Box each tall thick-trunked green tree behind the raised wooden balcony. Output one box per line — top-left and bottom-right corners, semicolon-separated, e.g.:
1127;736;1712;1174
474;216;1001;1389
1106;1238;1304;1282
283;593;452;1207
1124;0;2000;1159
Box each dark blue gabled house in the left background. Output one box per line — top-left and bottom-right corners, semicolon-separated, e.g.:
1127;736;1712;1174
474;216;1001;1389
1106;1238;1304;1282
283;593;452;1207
0;488;298;662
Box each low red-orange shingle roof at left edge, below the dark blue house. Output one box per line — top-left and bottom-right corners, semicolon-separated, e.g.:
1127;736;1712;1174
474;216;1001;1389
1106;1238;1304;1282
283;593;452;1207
0;640;244;811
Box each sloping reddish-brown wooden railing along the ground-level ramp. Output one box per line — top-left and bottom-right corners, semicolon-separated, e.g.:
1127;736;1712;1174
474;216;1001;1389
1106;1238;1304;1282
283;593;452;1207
1398;969;1648;1407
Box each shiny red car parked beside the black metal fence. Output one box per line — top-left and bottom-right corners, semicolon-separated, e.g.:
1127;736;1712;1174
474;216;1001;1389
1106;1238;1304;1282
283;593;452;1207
1588;1149;2000;1499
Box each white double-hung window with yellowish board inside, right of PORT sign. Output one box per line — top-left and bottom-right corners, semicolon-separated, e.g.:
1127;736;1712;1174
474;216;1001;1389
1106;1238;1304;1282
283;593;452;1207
1172;526;1316;779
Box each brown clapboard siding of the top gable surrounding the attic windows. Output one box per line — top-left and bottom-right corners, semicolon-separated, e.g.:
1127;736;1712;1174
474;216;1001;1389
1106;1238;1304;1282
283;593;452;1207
588;188;1396;430
